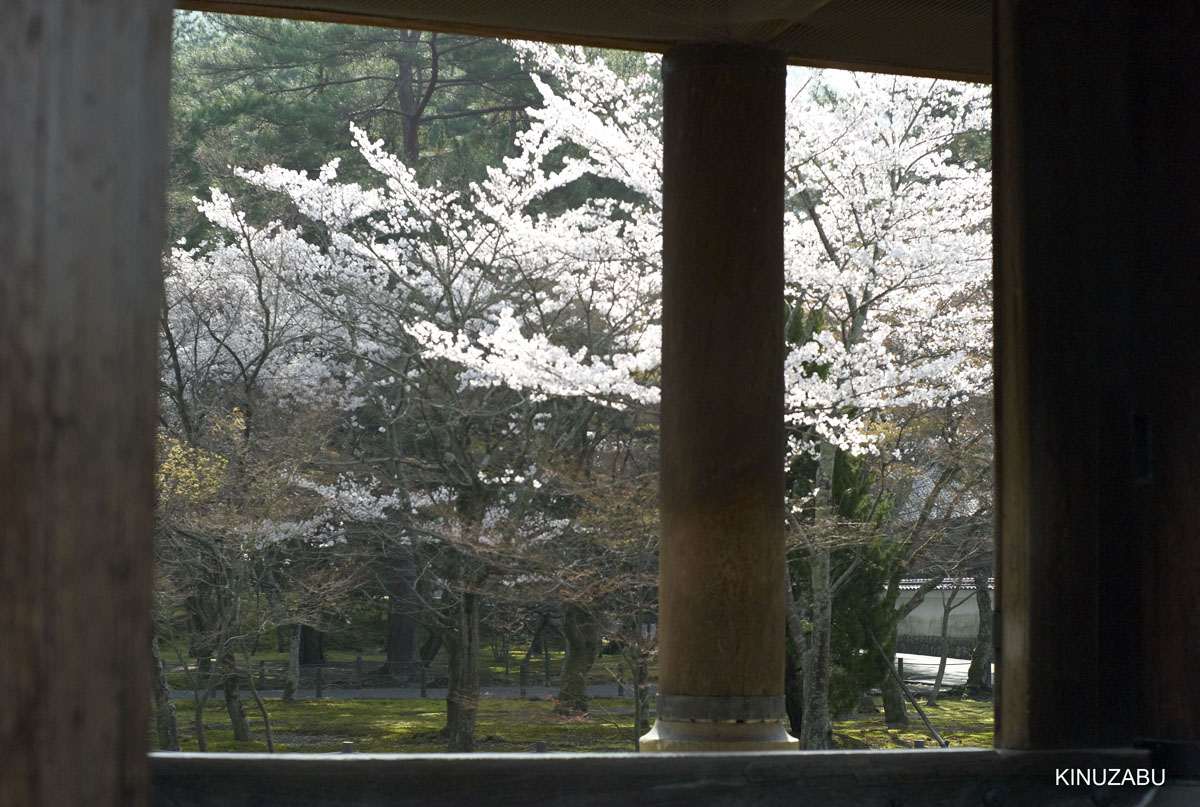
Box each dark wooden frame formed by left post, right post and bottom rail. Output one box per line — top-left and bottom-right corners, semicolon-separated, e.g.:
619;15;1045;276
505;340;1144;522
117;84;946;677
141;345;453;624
0;0;1200;807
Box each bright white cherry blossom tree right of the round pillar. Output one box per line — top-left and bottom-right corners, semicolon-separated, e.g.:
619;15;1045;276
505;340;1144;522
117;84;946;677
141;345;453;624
785;74;991;748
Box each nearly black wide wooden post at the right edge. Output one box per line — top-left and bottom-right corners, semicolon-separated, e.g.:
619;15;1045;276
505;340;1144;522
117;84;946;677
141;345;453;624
994;0;1200;749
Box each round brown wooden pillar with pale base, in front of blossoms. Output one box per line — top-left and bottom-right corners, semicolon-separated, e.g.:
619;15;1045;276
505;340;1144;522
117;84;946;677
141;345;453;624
641;44;796;751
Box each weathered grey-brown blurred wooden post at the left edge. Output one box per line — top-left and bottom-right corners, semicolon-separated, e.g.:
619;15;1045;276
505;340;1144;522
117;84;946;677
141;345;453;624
0;0;170;807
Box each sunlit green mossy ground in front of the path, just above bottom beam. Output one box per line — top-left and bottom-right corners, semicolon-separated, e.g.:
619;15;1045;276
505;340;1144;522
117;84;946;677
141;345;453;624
176;693;992;753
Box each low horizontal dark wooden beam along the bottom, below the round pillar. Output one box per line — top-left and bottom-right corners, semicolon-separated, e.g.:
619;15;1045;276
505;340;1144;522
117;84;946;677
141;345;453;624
151;748;1171;807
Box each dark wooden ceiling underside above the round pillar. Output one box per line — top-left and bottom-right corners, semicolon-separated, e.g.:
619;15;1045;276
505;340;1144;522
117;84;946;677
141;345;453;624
176;0;991;82
